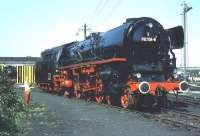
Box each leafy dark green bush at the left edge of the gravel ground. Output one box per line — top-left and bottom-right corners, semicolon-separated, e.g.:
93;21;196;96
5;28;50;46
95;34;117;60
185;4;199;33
0;72;24;136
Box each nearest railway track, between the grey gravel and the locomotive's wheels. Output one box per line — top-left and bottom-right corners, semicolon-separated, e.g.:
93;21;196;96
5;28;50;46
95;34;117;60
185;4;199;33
69;95;200;133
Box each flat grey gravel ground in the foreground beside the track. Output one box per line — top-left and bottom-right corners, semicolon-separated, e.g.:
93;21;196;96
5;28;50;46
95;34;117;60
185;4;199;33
21;89;197;136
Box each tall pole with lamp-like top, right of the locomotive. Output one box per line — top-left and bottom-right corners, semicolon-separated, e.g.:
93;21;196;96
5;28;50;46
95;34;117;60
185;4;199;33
181;1;192;78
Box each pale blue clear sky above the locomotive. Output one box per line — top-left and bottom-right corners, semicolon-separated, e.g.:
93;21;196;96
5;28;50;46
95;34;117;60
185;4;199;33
0;0;200;67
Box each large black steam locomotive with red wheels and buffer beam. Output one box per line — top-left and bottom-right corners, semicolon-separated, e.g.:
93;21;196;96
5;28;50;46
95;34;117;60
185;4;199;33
36;17;188;108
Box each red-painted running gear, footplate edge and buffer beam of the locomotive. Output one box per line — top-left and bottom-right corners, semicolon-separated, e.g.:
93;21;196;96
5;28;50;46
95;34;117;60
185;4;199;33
39;58;188;108
